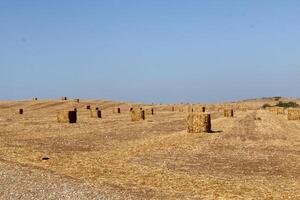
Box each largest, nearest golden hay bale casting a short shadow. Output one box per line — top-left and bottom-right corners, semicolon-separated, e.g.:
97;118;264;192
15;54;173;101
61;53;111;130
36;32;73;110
187;113;211;133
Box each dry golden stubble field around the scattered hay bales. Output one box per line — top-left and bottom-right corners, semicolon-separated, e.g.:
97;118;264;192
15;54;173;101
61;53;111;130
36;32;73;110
0;99;300;199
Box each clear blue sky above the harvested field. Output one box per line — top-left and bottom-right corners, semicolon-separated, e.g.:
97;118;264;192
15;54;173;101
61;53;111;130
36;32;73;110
0;0;300;103
